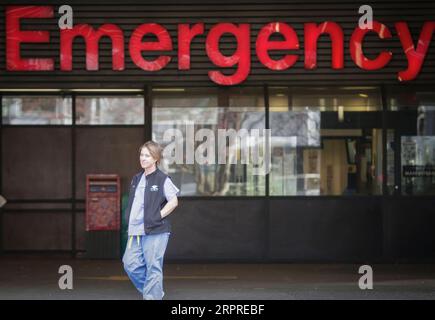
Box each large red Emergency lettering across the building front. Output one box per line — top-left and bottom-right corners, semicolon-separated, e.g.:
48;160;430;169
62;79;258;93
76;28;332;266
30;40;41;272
5;6;435;86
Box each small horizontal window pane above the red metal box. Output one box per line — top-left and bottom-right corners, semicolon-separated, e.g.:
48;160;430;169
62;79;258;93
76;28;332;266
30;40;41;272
76;95;144;125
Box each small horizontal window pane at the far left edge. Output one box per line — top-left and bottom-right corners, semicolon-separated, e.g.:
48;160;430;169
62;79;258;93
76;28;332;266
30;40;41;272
2;96;72;125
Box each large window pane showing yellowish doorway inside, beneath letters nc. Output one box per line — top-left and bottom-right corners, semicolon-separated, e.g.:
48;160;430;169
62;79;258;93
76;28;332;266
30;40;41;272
269;87;382;195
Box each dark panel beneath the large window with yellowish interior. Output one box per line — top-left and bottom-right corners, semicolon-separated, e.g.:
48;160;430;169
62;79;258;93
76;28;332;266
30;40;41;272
269;197;382;261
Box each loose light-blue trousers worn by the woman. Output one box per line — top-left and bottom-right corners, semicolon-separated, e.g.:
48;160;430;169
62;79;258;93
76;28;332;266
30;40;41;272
122;232;170;300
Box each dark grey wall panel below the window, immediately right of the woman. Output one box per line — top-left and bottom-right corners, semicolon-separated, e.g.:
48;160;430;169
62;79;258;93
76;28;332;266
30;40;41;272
167;199;265;260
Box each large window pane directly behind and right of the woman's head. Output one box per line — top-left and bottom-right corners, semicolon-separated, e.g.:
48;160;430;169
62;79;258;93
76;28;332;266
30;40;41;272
153;88;265;196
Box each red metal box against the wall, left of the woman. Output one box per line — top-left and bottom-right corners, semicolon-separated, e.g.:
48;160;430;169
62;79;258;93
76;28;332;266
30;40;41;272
86;174;121;231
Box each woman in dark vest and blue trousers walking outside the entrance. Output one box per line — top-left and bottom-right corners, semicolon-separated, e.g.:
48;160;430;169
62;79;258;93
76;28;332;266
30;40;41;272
122;141;179;300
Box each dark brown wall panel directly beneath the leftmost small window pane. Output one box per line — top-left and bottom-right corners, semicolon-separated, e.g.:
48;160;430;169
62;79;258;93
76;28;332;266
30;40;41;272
2;127;71;199
